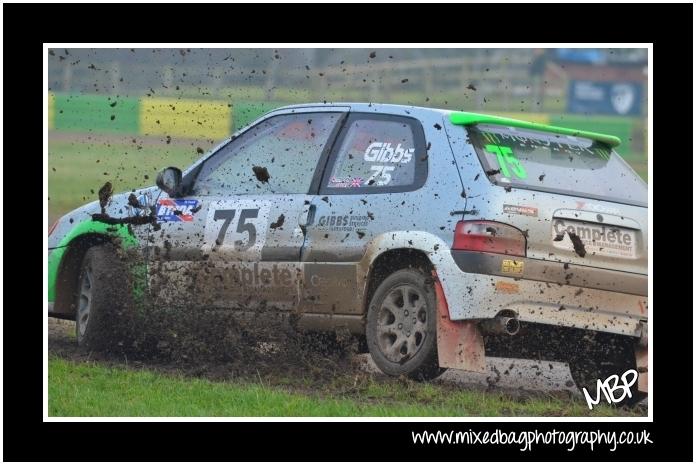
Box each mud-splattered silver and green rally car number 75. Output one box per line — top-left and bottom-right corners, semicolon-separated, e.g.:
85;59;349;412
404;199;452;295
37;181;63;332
48;103;648;397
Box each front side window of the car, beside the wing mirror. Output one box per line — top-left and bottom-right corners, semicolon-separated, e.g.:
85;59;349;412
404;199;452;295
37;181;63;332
193;112;341;195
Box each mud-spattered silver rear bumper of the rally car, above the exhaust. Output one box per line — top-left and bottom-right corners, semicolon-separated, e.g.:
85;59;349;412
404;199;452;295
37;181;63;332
438;251;648;338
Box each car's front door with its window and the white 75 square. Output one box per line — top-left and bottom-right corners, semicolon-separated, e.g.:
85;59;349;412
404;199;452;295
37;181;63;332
150;109;350;310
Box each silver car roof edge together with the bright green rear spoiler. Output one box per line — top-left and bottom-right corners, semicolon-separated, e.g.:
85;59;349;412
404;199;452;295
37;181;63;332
278;102;621;147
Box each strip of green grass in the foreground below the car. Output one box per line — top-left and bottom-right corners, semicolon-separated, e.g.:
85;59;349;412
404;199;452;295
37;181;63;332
48;356;641;417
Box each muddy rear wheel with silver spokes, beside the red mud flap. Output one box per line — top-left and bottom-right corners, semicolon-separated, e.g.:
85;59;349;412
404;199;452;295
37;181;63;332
366;269;444;380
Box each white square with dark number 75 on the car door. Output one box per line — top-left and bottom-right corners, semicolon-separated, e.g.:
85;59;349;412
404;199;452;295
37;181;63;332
203;200;270;258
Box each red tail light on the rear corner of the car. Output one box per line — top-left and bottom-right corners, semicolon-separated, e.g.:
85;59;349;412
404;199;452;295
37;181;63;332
452;220;527;257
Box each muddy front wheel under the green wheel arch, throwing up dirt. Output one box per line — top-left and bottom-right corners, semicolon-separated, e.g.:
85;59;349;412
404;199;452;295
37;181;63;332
75;244;132;350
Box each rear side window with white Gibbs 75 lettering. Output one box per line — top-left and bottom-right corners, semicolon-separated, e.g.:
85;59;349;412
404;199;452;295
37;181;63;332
322;114;428;194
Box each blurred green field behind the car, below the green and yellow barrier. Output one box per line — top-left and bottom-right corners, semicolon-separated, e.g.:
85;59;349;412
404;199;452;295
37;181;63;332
48;133;648;223
